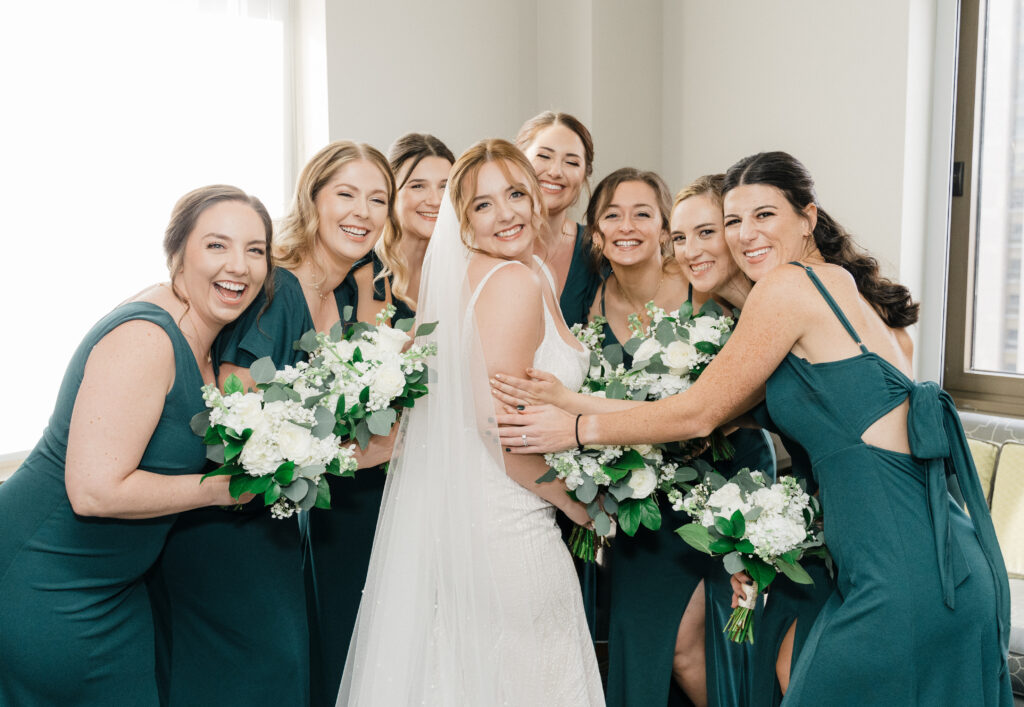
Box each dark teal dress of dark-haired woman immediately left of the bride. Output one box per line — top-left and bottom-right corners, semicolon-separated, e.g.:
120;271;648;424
301;253;391;707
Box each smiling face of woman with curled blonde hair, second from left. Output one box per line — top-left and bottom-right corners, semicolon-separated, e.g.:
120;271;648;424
313;160;388;264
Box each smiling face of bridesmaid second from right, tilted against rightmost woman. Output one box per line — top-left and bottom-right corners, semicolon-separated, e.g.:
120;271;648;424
670;194;739;292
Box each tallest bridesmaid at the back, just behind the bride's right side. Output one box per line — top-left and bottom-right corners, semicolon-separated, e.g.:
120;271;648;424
515;111;600;327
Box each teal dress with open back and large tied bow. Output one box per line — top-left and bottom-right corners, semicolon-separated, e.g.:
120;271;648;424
766;263;1013;707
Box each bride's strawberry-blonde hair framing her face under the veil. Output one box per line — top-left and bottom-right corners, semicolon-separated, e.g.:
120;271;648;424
449;138;552;253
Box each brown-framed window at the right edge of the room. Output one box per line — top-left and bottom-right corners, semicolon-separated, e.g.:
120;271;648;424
944;0;1024;415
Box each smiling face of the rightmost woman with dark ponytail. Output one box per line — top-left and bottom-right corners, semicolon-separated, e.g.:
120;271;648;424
724;184;817;282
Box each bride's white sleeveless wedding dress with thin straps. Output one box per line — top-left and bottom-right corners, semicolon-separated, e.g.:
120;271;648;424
468;261;604;707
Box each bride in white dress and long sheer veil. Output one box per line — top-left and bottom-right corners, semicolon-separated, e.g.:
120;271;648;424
338;139;604;707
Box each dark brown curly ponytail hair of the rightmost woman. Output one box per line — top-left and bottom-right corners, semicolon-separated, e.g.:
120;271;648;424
722;152;920;329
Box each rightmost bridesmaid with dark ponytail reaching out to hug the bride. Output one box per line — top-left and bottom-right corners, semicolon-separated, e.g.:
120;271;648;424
499;152;1013;707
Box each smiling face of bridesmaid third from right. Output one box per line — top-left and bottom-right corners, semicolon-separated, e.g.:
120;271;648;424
595;181;667;265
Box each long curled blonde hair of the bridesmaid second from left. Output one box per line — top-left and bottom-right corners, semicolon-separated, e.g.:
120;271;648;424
273;140;409;295
